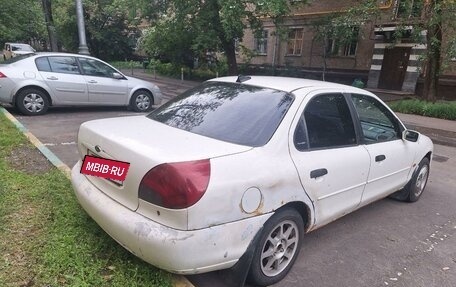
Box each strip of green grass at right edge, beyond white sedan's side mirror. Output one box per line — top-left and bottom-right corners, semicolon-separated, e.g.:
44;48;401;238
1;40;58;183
388;100;456;120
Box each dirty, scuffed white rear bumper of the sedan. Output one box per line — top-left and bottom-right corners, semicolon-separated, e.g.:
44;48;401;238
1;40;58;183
71;161;271;274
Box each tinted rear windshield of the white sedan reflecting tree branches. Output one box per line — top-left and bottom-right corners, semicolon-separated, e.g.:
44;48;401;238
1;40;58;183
147;82;294;147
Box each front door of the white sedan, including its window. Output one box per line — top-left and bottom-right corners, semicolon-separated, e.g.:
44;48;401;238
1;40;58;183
352;94;415;205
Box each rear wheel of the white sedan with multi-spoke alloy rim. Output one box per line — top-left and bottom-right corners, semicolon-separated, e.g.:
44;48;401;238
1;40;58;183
247;208;304;286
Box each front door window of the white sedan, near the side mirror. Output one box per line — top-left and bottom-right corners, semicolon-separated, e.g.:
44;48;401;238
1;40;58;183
352;94;402;144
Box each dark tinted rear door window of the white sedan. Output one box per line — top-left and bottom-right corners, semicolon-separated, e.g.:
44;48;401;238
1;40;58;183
304;93;357;148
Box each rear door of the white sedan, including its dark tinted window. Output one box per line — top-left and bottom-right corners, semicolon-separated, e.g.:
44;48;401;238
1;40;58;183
290;91;370;227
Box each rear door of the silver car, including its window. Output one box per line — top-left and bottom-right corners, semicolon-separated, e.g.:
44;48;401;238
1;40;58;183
35;56;89;104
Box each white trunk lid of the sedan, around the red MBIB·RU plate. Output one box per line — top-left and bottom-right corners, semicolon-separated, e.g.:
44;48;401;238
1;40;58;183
78;116;251;210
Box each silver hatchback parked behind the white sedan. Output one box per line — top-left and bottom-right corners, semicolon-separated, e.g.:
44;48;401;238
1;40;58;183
0;53;162;115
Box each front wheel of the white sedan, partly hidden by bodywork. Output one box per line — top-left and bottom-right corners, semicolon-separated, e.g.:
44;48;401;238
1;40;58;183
390;157;430;202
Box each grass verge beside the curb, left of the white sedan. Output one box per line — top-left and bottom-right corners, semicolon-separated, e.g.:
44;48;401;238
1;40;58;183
0;113;172;287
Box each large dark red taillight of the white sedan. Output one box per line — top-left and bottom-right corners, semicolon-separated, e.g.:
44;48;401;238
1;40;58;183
139;159;211;209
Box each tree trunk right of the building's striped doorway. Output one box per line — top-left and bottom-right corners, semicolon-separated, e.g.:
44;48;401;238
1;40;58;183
423;0;442;102
